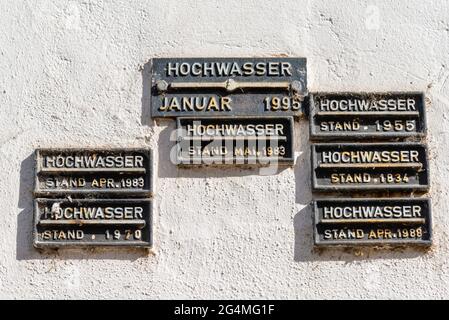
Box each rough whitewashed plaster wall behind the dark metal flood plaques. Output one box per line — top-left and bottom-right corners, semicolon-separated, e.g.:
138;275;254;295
0;0;449;299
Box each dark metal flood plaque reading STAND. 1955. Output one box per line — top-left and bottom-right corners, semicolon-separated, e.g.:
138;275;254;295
309;92;426;139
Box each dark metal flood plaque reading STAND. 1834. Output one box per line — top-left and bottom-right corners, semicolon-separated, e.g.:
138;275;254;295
312;143;429;192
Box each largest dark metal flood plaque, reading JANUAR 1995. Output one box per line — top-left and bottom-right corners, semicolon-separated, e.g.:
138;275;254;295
151;57;307;118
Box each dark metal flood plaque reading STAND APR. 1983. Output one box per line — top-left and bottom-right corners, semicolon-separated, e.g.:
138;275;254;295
35;149;151;197
